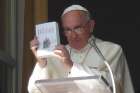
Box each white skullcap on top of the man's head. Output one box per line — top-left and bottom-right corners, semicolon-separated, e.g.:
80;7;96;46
62;5;89;16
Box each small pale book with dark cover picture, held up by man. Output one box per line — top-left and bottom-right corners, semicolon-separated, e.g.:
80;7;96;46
35;22;60;57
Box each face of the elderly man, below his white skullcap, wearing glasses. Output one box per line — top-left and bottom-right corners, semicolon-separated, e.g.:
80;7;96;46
62;11;92;50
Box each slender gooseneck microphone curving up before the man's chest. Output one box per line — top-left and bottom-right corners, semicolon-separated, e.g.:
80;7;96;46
89;37;116;93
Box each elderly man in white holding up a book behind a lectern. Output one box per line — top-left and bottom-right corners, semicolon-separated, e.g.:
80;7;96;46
28;5;134;93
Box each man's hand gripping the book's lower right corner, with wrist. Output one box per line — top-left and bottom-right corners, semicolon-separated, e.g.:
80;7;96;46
54;45;73;69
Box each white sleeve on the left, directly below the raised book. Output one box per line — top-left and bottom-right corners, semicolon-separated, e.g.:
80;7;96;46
28;58;66;93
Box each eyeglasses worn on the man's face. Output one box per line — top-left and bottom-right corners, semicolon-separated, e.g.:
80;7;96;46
64;21;89;33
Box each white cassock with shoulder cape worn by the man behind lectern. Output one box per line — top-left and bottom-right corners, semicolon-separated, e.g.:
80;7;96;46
28;36;134;93
